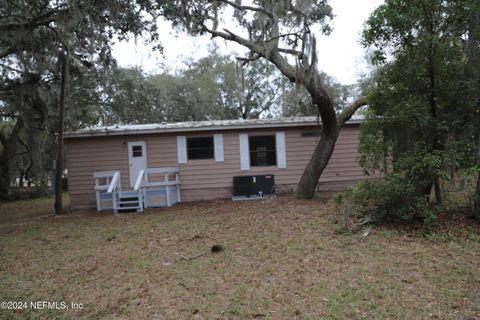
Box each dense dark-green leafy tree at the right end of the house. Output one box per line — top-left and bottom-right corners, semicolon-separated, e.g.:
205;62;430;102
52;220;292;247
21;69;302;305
360;0;479;220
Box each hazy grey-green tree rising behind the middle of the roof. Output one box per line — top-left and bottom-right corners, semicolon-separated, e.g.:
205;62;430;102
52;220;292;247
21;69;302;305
148;52;285;121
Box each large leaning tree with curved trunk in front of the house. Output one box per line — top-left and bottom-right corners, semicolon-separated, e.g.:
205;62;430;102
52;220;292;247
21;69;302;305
161;0;366;198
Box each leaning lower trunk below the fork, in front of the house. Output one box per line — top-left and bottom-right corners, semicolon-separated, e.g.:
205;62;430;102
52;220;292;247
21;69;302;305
296;130;339;199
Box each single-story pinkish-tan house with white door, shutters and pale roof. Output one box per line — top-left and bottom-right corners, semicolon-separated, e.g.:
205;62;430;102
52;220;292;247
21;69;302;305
65;117;364;209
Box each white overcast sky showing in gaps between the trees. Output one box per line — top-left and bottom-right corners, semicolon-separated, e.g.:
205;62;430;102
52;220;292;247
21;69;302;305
113;0;384;84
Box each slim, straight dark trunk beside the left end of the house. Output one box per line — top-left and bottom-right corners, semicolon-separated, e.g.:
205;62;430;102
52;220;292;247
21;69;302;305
54;50;69;214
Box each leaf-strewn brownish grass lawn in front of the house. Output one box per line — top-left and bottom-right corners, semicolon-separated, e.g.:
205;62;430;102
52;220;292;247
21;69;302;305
0;196;480;319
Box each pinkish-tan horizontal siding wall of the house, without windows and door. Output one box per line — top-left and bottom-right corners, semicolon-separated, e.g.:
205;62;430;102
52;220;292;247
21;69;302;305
66;124;365;209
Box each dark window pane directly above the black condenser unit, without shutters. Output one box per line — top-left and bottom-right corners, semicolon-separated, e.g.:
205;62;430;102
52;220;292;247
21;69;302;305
248;136;277;167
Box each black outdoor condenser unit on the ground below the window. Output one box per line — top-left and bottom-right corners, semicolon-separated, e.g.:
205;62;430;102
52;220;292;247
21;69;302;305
233;174;275;198
